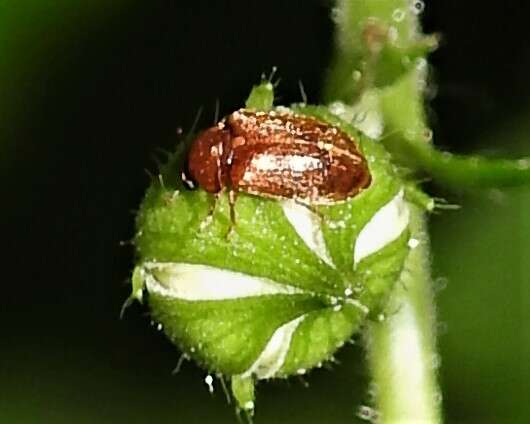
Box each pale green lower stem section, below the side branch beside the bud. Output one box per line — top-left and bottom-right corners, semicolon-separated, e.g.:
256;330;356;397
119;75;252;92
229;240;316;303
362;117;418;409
366;205;441;423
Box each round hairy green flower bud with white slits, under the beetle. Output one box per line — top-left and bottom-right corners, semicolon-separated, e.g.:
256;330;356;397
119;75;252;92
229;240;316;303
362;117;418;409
128;84;409;410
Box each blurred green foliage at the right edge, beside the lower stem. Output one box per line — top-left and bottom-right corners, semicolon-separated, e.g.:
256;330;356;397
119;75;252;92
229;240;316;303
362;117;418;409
432;114;530;423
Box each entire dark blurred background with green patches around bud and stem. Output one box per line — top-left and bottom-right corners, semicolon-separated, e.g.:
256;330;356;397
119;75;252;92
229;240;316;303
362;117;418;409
0;0;530;424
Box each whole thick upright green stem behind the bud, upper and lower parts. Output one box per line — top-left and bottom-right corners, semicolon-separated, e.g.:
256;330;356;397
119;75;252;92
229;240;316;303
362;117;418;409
324;0;441;423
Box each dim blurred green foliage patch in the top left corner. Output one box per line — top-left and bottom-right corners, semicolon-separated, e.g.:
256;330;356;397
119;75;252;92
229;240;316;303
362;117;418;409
0;0;127;160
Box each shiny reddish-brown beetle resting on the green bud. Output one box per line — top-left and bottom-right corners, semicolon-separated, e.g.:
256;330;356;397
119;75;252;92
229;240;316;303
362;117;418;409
188;109;371;211
